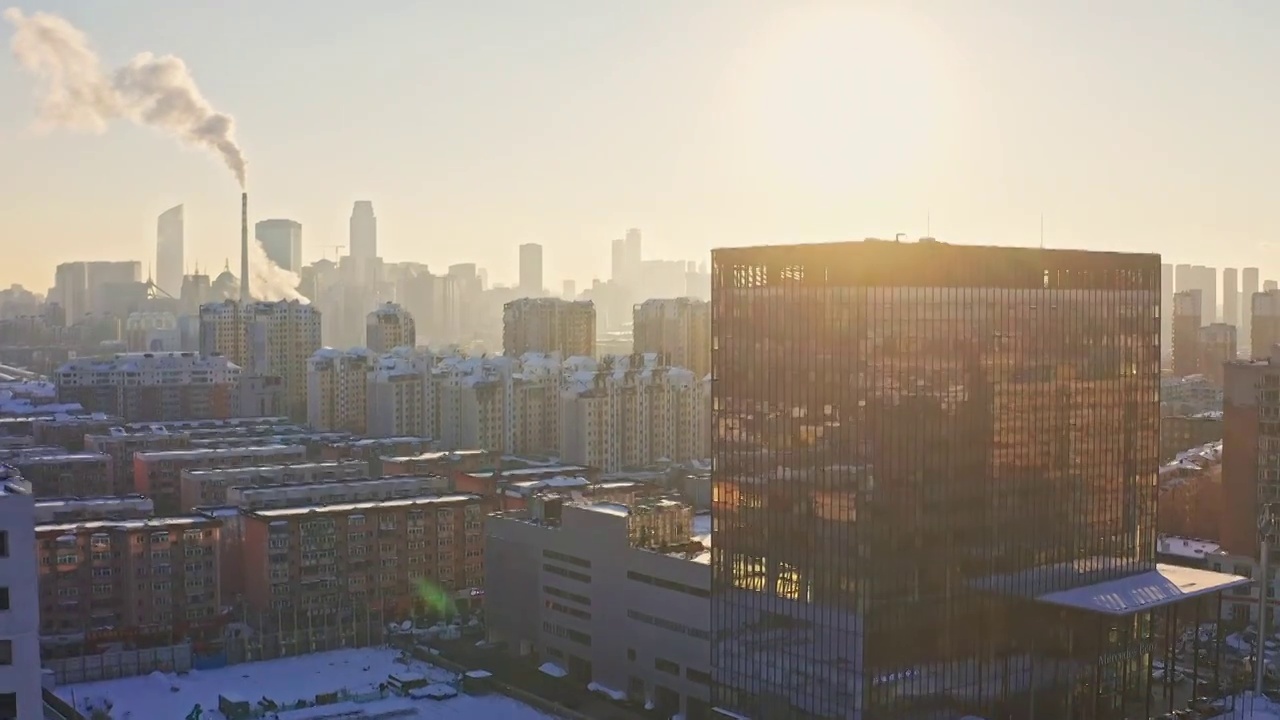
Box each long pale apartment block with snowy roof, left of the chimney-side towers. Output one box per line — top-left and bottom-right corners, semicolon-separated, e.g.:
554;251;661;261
55;352;241;421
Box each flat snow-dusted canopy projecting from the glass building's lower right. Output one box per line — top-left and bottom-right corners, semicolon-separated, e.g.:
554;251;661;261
1036;564;1253;615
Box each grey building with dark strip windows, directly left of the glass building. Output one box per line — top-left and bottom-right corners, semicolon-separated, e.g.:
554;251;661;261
485;500;712;720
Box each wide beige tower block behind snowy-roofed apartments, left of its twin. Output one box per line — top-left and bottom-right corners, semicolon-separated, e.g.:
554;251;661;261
502;297;595;357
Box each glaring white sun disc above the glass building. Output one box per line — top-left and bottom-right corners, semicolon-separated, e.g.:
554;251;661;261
739;6;940;193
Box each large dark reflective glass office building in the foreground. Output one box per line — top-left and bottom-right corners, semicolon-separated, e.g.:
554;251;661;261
712;241;1161;720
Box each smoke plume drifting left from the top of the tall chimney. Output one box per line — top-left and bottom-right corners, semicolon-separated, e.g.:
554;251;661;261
4;8;246;187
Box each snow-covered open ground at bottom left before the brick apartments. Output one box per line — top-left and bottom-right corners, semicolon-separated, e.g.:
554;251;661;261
56;648;554;720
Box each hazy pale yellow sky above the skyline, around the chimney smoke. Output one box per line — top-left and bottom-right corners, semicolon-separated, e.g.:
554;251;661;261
0;0;1280;291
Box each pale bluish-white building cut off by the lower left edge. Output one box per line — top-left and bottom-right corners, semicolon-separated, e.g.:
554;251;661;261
0;465;44;720
